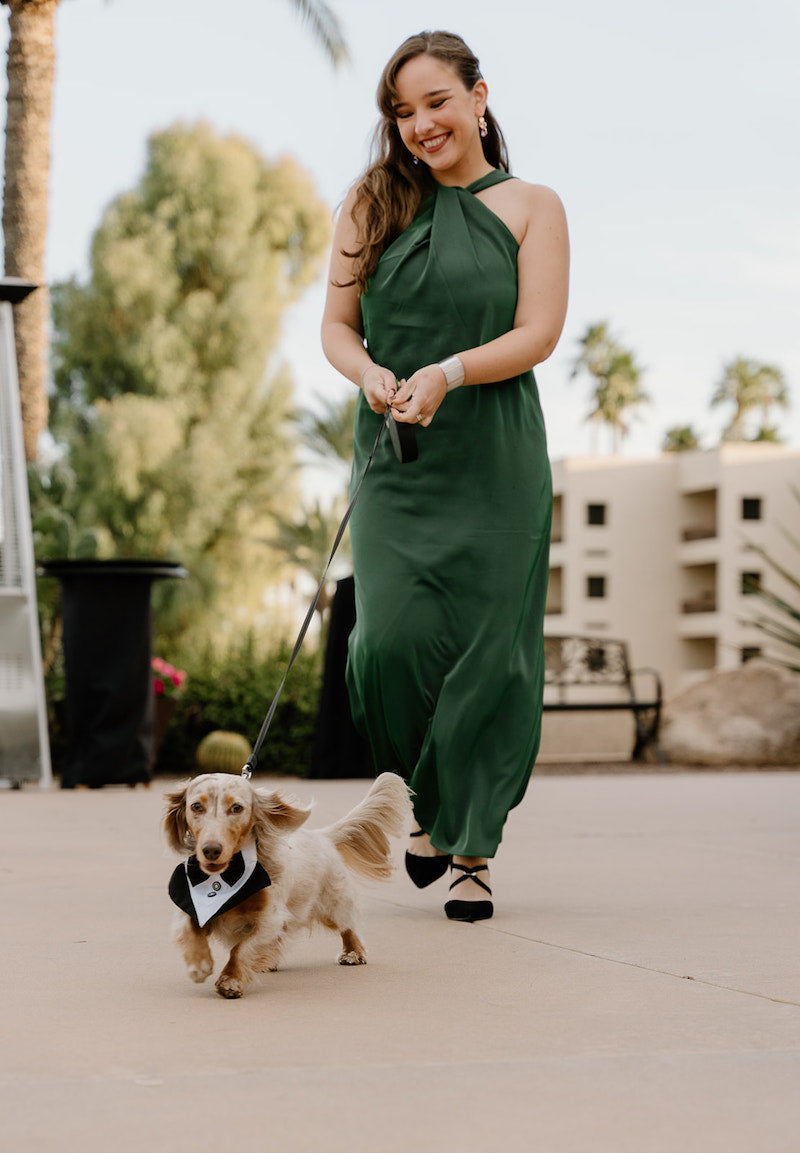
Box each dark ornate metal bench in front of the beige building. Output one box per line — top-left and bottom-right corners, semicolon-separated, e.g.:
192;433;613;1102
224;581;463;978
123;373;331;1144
544;636;664;763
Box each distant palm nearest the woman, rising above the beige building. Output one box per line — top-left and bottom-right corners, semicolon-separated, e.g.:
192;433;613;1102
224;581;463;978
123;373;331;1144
572;321;650;452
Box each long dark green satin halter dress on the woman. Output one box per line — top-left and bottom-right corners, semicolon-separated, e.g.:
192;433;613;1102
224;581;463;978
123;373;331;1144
347;171;552;857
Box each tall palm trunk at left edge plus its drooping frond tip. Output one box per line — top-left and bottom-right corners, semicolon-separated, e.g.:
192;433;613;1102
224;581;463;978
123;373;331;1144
0;0;348;460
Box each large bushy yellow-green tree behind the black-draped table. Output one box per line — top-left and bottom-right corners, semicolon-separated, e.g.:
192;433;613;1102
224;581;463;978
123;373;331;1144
43;125;329;641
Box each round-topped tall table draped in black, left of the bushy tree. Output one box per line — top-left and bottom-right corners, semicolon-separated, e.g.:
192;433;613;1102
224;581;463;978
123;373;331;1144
41;560;186;789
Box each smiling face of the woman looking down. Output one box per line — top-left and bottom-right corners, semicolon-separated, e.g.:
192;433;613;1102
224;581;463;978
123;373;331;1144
393;55;486;183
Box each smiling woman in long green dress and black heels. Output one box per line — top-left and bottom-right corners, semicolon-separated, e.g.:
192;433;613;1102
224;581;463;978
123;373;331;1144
323;32;568;921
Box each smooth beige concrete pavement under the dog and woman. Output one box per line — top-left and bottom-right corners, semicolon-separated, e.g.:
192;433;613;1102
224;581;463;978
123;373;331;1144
0;773;800;1153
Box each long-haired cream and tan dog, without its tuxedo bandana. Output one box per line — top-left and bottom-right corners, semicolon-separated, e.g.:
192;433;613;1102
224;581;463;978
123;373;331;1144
164;773;410;997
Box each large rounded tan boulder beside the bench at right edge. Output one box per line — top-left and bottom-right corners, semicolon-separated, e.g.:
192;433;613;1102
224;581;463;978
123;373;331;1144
661;661;800;766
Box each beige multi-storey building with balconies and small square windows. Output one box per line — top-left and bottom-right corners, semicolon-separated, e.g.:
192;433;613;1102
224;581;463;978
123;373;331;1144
545;444;800;698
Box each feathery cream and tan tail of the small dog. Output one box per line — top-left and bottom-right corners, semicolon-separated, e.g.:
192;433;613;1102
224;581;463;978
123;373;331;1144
323;773;412;881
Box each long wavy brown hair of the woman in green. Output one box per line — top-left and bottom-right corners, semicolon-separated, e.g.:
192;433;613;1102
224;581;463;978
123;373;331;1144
342;32;508;292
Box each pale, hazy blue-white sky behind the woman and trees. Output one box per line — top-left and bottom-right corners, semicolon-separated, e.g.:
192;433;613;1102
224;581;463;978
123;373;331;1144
2;0;800;481
